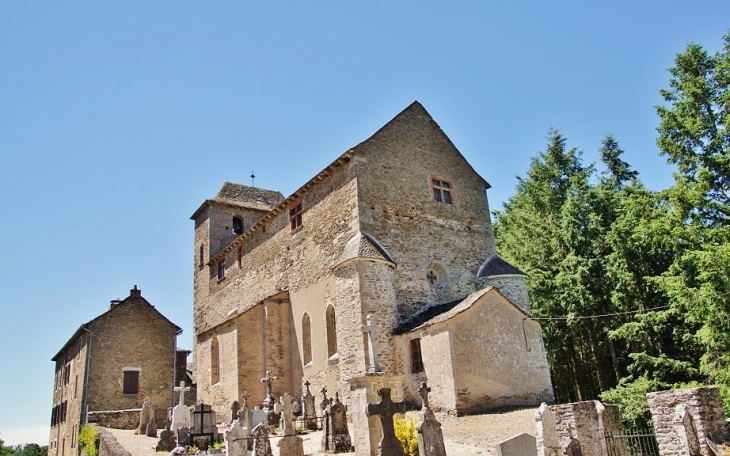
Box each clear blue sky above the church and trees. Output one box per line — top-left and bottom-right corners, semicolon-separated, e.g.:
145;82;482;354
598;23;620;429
0;0;730;444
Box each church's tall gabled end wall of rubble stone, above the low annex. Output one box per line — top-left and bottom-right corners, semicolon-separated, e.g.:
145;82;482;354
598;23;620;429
354;104;495;321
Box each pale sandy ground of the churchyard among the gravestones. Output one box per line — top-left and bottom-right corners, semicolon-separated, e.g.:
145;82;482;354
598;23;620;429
107;408;537;456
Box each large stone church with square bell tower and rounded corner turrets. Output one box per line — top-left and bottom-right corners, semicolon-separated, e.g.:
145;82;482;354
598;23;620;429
191;102;553;416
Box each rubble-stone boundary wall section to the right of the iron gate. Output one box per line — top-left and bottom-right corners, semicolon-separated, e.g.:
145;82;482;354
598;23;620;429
646;386;730;456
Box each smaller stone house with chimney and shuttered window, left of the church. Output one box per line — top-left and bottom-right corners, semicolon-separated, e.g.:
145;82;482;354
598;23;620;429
48;285;189;456
